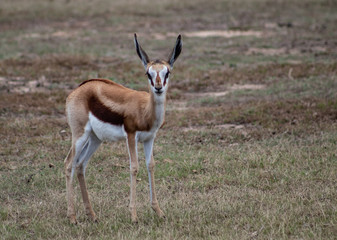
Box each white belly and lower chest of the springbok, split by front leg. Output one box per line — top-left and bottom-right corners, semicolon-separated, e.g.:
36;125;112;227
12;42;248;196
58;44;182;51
89;113;157;142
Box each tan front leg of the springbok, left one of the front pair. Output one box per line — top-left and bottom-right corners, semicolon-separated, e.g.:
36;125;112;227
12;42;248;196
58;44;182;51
127;133;139;223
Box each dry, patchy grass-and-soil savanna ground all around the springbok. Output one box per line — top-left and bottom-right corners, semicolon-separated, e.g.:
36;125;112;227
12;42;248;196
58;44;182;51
0;0;337;239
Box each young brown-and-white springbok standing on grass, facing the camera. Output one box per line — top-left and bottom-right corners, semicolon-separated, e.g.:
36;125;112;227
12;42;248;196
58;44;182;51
65;34;182;223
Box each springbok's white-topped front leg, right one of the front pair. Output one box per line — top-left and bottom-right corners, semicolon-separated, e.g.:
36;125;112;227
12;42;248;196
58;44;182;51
144;139;165;218
